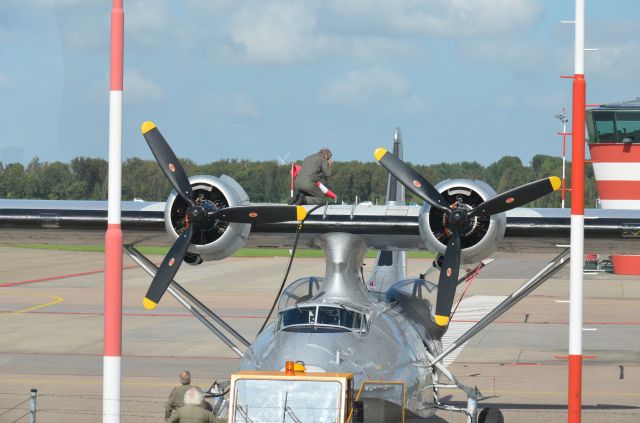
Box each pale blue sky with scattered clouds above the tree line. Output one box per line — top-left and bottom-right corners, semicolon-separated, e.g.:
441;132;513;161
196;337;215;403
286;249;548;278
0;0;640;164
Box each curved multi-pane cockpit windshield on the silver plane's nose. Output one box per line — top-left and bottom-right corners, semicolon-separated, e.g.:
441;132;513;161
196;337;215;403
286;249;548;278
279;306;366;331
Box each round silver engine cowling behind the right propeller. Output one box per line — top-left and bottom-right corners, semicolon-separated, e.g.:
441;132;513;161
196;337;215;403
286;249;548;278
419;179;507;262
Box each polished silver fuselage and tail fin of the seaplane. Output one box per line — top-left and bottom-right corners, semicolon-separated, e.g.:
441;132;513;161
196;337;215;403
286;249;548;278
240;130;442;417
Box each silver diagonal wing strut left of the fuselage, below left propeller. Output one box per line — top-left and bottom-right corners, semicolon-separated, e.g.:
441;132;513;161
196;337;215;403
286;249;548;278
124;245;250;357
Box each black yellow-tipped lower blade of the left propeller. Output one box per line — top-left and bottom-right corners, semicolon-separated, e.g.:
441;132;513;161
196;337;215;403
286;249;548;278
142;226;193;310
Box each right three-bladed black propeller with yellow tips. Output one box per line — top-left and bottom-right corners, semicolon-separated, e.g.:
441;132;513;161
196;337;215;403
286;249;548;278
373;148;561;327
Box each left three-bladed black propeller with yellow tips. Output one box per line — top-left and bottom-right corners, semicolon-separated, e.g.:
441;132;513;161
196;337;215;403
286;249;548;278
140;122;307;310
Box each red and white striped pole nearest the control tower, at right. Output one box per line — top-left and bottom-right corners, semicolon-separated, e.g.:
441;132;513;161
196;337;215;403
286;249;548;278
568;0;586;423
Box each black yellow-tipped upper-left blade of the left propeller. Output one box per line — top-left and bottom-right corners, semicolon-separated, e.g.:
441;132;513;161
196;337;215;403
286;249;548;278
140;121;193;206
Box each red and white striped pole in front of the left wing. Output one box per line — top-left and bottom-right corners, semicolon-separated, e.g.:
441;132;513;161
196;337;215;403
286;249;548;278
102;0;124;423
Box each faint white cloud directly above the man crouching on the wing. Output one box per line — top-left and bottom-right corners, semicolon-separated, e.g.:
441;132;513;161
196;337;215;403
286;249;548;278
319;67;427;112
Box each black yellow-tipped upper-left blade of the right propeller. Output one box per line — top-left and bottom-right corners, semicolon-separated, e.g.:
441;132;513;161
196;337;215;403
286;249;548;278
373;148;448;211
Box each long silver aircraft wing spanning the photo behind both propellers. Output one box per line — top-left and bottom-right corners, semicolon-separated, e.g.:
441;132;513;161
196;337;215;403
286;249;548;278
0;200;640;254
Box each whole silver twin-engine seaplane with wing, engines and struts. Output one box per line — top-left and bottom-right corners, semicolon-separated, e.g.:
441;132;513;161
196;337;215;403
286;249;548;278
0;123;640;422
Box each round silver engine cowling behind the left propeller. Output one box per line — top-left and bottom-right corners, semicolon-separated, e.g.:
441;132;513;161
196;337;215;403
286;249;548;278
164;175;251;264
